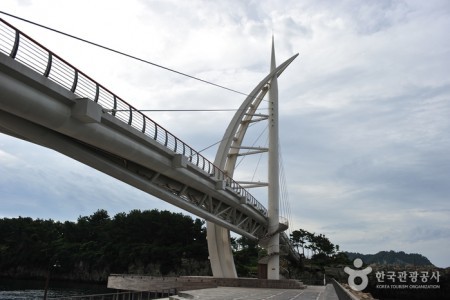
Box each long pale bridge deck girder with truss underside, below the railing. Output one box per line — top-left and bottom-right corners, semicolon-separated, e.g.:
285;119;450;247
0;53;267;239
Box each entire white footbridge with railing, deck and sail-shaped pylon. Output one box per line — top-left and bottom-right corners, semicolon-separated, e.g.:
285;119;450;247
0;19;297;279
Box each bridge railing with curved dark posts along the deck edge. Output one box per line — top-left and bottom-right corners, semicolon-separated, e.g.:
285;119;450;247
0;18;267;216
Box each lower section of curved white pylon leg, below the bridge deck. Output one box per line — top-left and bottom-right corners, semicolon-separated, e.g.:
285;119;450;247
206;222;237;278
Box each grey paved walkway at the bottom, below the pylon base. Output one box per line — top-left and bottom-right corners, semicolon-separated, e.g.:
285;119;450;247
166;284;338;300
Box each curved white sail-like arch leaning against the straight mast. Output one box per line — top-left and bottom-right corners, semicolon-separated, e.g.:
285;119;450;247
206;54;298;278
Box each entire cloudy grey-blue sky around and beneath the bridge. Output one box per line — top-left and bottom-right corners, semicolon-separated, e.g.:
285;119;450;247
0;0;450;267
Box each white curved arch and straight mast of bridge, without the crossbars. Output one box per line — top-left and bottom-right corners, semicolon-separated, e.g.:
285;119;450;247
207;38;298;279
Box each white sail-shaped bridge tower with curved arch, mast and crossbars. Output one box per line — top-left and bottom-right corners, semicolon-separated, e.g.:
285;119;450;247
207;37;298;279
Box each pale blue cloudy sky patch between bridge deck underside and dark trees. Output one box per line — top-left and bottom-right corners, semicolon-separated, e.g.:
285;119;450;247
0;135;174;221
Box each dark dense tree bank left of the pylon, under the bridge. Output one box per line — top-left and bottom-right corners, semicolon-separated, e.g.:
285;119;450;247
0;210;208;280
